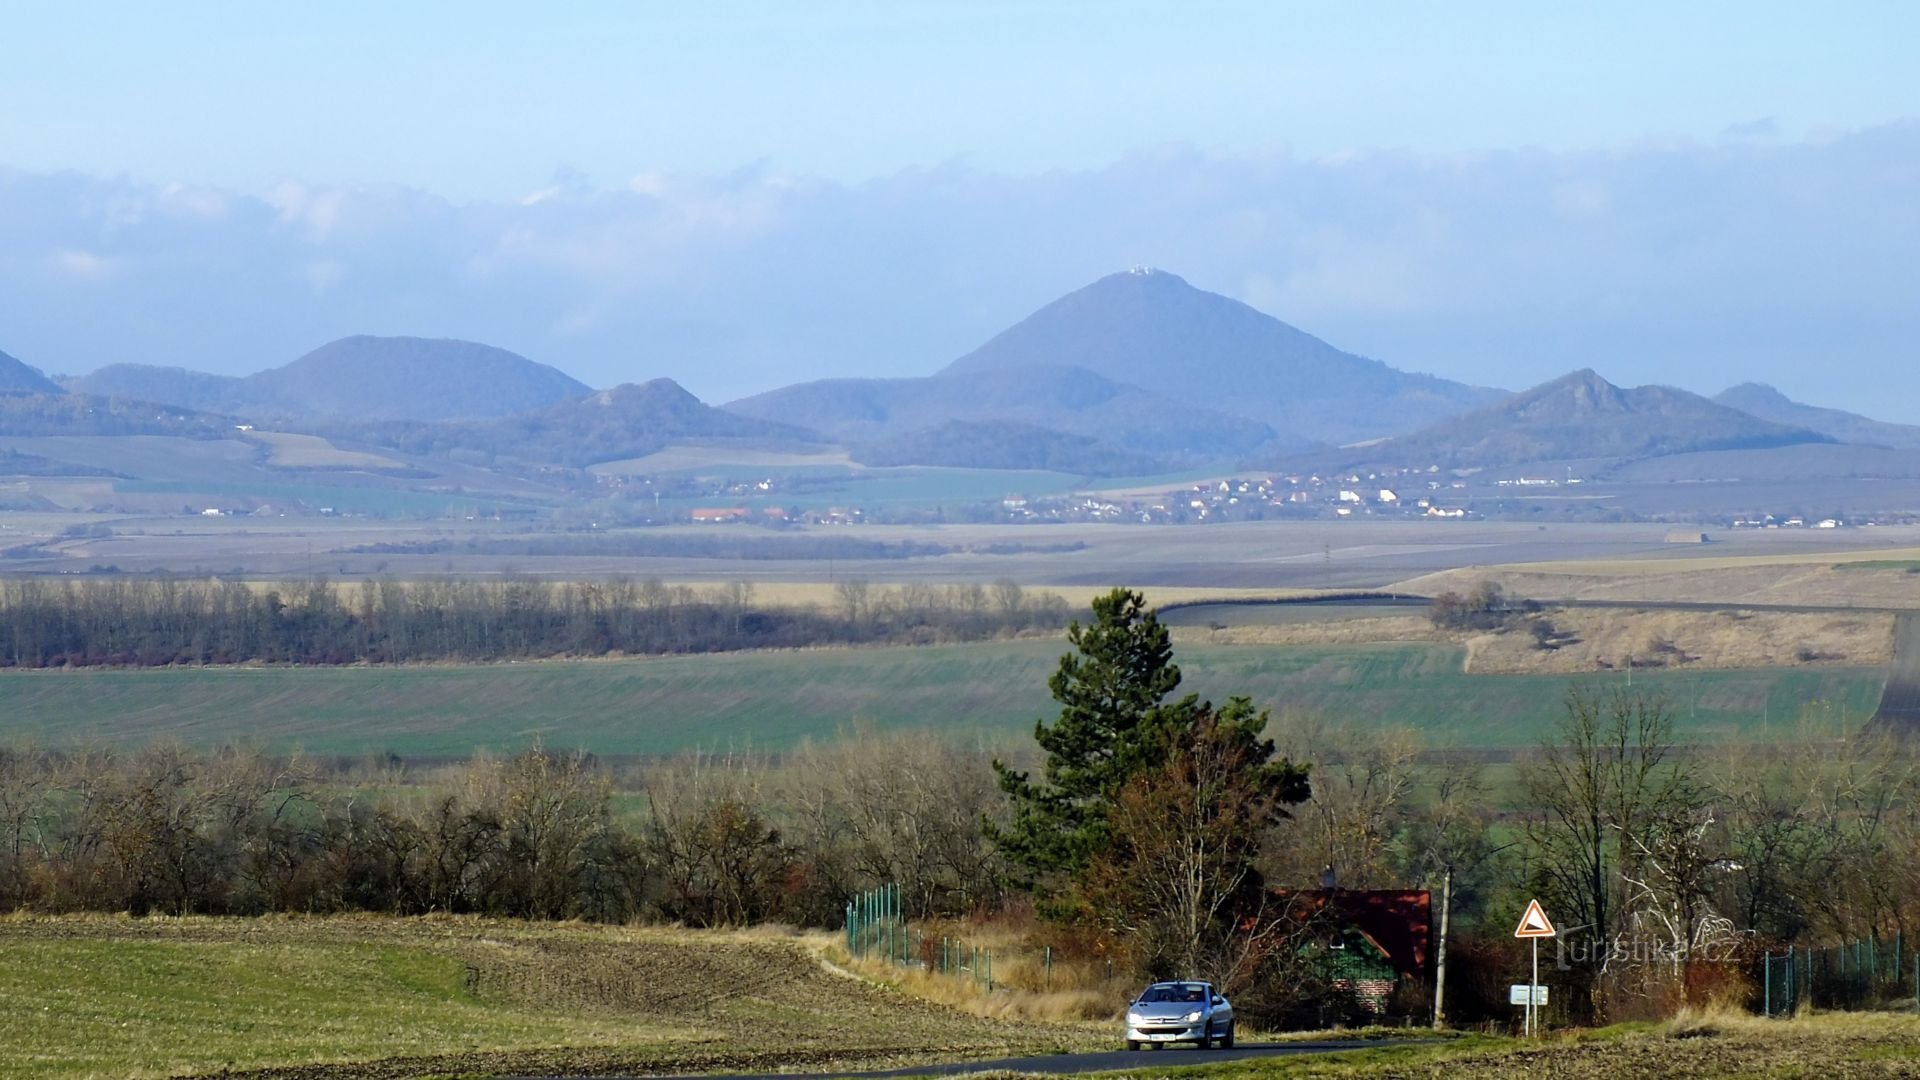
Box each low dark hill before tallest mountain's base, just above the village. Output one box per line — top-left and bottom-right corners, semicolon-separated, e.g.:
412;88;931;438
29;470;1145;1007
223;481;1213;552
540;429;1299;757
852;421;1164;477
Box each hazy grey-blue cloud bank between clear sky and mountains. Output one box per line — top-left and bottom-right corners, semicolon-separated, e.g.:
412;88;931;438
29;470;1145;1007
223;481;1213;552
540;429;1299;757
0;123;1920;421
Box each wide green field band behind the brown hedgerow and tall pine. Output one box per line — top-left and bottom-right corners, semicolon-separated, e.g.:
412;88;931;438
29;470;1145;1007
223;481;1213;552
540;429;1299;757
0;640;1885;757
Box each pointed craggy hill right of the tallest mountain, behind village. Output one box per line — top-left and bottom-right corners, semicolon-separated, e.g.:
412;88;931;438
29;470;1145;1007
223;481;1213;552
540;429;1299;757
1325;371;1832;469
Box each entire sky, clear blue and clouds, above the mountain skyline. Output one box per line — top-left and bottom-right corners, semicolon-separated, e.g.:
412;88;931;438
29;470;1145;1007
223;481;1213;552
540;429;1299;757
0;0;1920;421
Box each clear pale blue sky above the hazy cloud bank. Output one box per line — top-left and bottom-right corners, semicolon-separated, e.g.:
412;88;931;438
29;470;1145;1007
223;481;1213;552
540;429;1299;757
0;0;1920;200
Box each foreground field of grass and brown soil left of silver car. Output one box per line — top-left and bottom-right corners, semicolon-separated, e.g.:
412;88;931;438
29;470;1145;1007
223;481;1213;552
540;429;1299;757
0;917;1091;1080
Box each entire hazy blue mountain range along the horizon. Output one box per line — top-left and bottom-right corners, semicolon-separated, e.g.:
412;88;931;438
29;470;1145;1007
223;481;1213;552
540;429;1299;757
11;271;1920;477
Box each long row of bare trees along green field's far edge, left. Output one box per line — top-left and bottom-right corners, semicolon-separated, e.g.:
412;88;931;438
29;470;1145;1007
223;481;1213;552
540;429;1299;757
0;578;1068;667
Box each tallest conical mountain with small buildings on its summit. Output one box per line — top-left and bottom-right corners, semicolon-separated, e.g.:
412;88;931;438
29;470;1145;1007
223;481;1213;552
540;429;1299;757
943;271;1501;442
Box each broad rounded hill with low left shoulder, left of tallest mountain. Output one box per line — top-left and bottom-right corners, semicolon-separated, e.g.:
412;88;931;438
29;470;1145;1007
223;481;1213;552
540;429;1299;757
69;334;591;421
